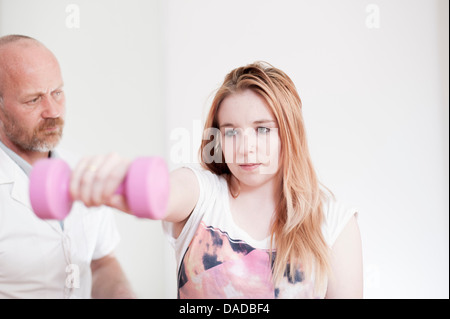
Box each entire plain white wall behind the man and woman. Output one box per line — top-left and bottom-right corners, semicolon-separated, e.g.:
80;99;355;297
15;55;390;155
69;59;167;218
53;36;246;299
0;0;449;298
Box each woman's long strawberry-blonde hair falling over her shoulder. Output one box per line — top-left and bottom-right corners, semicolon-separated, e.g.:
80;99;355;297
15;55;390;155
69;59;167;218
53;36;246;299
199;62;330;291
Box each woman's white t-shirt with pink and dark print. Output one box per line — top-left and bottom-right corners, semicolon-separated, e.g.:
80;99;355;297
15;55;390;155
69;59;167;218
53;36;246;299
163;167;357;299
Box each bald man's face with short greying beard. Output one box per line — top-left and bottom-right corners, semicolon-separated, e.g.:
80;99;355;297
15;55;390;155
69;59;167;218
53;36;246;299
0;43;65;152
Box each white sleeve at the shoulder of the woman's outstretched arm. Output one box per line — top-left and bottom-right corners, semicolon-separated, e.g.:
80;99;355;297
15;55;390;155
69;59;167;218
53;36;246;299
162;166;220;265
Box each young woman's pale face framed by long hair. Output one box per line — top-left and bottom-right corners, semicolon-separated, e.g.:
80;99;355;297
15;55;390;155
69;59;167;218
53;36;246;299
218;89;281;187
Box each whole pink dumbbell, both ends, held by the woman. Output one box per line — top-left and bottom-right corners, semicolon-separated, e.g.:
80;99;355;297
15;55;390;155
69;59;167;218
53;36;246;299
30;157;169;220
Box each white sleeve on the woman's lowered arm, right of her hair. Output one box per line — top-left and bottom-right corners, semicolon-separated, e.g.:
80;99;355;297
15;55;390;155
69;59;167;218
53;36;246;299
322;199;358;247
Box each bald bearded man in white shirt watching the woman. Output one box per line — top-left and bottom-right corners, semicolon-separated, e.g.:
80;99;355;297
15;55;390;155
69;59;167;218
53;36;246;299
0;35;134;298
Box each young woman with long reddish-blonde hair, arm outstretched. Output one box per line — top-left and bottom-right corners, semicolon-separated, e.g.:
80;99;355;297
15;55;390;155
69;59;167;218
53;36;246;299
71;63;362;298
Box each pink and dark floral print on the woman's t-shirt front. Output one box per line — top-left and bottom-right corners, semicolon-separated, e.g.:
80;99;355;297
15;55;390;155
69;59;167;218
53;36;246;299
178;221;314;299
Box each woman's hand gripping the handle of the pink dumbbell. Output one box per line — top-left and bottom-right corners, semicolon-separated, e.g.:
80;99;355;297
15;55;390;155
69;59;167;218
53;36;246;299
70;153;131;214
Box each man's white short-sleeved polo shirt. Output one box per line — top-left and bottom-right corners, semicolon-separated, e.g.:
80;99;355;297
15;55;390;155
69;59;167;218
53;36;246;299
0;147;119;298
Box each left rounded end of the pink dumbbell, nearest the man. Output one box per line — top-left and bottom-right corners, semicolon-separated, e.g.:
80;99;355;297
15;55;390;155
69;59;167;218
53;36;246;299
30;159;73;220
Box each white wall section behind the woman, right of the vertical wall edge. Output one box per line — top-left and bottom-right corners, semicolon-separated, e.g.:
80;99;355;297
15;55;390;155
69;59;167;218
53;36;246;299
163;0;449;298
